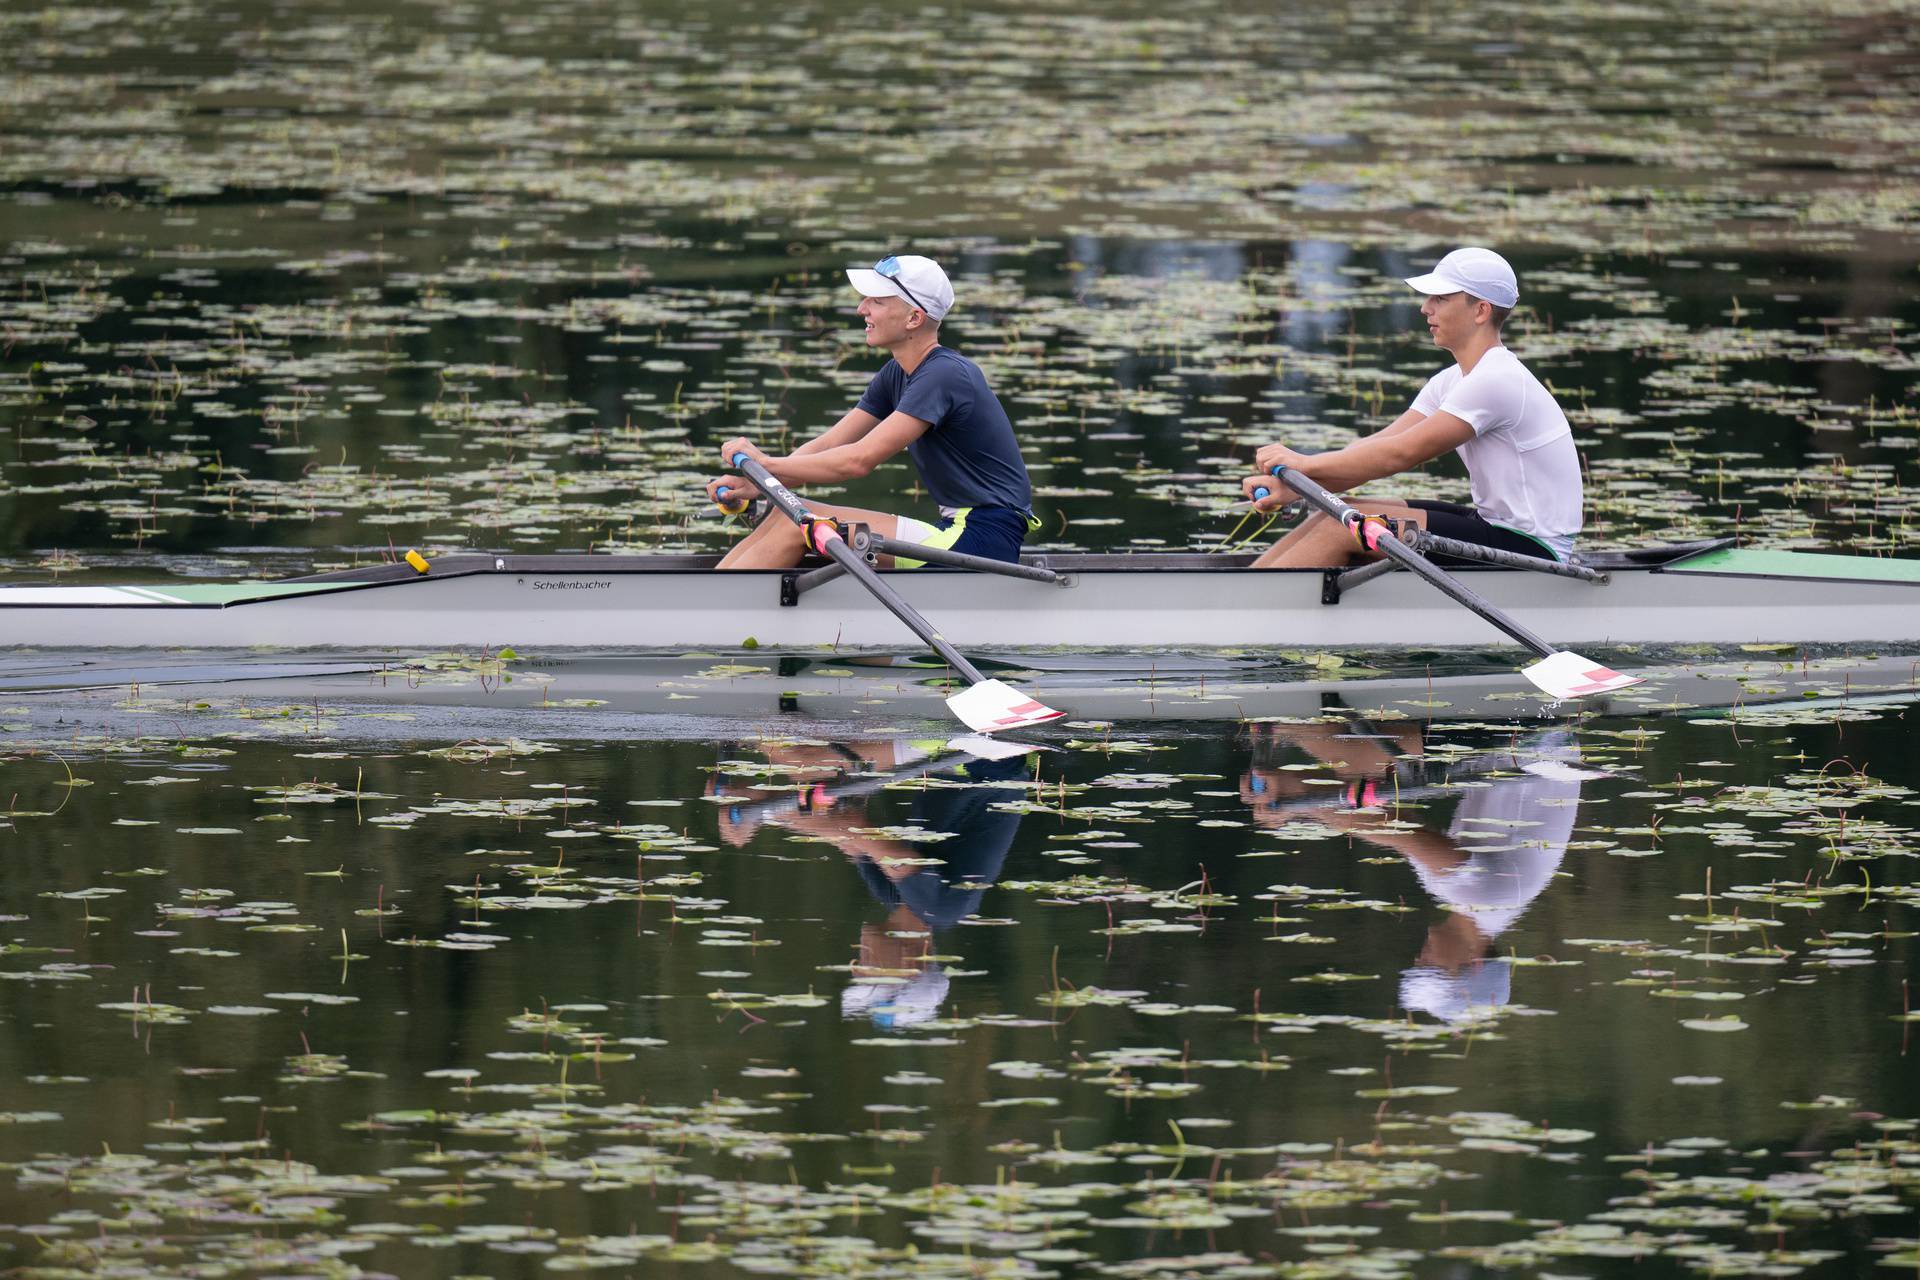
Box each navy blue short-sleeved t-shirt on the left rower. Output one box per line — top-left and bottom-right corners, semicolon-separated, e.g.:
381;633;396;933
860;347;1033;510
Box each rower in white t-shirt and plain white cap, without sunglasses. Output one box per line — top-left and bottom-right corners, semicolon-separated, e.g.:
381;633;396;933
1240;248;1582;568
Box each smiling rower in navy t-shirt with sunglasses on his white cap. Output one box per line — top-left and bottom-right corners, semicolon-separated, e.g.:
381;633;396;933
707;255;1035;568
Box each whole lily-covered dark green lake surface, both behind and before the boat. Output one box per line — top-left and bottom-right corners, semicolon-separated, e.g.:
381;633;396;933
0;0;1920;1280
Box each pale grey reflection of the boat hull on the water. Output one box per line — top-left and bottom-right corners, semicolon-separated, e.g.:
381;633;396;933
0;652;1916;739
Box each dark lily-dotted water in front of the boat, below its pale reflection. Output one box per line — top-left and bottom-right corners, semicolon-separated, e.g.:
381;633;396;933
0;708;1920;1274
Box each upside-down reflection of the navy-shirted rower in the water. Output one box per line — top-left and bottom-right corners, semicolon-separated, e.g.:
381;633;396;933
720;739;1027;1027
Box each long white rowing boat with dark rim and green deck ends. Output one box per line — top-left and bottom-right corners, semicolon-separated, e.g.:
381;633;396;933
0;541;1920;651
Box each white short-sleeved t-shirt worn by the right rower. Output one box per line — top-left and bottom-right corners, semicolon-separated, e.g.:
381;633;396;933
1413;347;1584;558
